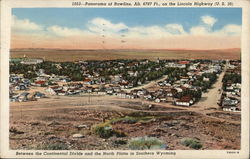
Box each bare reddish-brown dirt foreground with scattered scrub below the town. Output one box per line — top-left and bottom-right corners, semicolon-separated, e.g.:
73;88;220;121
10;95;241;150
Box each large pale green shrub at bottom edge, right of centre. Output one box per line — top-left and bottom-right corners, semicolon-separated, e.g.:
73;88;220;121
128;136;167;150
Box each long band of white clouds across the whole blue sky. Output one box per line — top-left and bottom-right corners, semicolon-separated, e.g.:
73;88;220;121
12;15;241;39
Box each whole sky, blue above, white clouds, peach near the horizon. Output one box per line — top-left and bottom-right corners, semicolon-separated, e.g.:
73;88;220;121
12;8;242;49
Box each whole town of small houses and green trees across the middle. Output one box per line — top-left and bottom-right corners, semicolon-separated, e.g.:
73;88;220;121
9;56;241;112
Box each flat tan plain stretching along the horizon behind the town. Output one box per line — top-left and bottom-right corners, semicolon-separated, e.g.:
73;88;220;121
10;49;240;62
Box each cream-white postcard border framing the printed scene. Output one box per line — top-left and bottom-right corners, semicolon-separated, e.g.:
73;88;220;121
0;0;250;159
